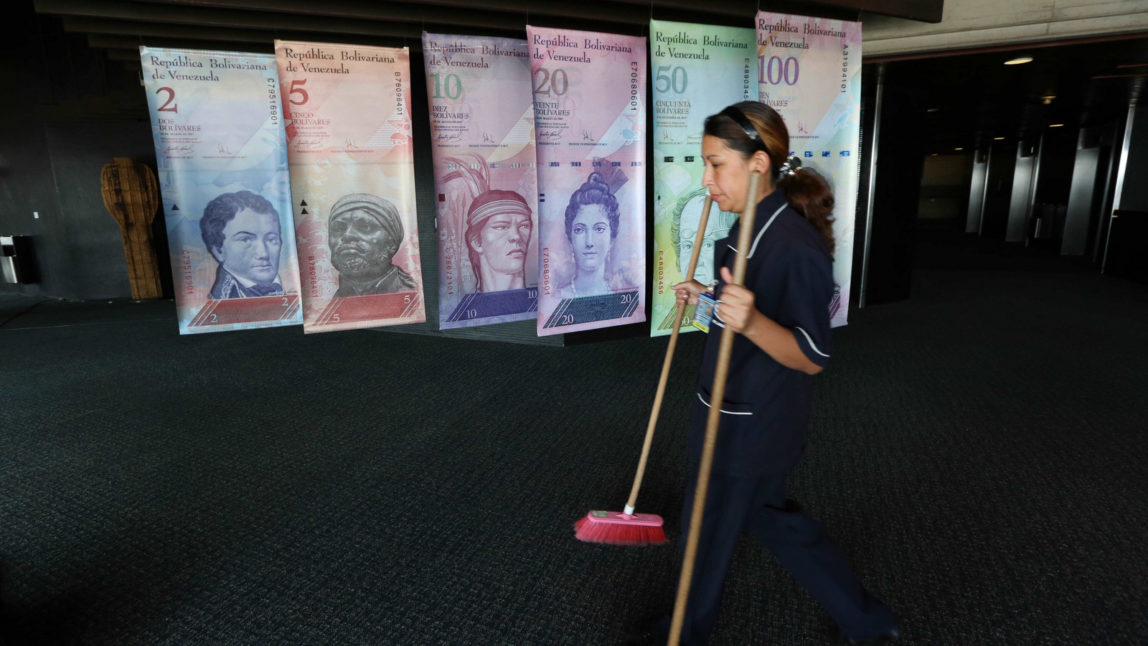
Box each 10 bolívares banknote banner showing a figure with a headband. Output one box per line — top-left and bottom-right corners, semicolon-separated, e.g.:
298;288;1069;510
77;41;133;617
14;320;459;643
422;33;538;329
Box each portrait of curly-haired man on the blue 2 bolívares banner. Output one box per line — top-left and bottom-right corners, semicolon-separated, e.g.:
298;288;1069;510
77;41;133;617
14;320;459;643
200;190;284;299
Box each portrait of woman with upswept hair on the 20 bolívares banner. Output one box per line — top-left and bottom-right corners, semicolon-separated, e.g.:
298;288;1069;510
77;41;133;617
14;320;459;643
558;172;633;298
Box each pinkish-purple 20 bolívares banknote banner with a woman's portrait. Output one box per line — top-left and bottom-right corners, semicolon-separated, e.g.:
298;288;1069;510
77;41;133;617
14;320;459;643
526;25;646;335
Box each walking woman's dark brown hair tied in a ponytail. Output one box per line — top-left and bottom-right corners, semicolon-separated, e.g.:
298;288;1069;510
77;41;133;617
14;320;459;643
704;101;835;254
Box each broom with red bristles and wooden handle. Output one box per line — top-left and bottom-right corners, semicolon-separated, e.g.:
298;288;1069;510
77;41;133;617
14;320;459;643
574;195;713;545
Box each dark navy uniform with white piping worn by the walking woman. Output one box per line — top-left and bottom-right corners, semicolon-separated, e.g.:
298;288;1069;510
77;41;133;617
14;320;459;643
682;189;895;645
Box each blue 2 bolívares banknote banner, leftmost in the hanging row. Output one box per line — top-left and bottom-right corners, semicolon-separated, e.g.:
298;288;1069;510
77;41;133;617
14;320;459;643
140;47;302;334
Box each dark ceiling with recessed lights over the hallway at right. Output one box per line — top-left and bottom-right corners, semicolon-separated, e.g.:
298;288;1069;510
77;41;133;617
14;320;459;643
885;37;1148;153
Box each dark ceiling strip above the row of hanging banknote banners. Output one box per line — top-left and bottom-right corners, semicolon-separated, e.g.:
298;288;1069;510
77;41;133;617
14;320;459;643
34;0;943;61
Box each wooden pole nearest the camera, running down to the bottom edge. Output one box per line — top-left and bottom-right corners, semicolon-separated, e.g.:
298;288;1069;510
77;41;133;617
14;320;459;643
668;171;761;646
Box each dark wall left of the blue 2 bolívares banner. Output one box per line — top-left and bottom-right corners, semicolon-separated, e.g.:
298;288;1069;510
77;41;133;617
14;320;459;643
0;2;157;299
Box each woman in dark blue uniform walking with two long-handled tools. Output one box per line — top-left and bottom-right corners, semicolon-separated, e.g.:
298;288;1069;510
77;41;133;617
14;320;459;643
674;101;898;645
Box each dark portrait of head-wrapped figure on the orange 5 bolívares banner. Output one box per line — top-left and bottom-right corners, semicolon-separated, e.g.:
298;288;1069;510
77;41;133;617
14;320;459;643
327;193;418;296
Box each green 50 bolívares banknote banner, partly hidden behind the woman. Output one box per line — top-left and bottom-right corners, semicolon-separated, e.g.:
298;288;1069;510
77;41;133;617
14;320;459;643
650;21;758;336
